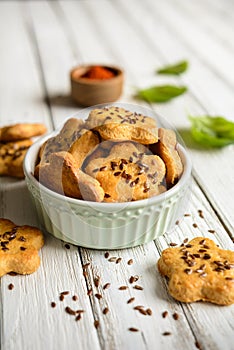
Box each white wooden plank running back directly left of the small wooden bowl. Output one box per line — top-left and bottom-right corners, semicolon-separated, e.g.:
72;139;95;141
25;2;82;127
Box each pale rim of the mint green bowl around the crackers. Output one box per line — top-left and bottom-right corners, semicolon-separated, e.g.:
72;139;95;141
23;129;192;210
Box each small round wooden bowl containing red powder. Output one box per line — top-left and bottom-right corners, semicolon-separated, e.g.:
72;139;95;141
70;65;124;107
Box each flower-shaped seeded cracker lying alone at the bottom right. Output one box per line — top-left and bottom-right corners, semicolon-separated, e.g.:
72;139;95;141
158;237;234;305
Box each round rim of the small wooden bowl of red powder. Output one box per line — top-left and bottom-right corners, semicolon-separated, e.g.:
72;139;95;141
70;63;124;85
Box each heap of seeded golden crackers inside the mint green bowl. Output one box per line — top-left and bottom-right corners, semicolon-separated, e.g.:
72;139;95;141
35;106;183;202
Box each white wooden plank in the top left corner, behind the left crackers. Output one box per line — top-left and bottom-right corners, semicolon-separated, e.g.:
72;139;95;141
0;1;50;127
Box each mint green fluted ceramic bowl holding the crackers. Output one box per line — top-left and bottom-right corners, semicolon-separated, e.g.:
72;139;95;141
24;132;192;249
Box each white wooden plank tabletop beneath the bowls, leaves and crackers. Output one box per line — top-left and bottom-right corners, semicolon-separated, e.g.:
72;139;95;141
0;0;234;350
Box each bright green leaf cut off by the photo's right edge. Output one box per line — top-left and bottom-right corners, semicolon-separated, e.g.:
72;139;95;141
189;115;234;147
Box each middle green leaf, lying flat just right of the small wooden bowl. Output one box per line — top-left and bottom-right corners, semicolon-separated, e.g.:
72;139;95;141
138;85;187;102
